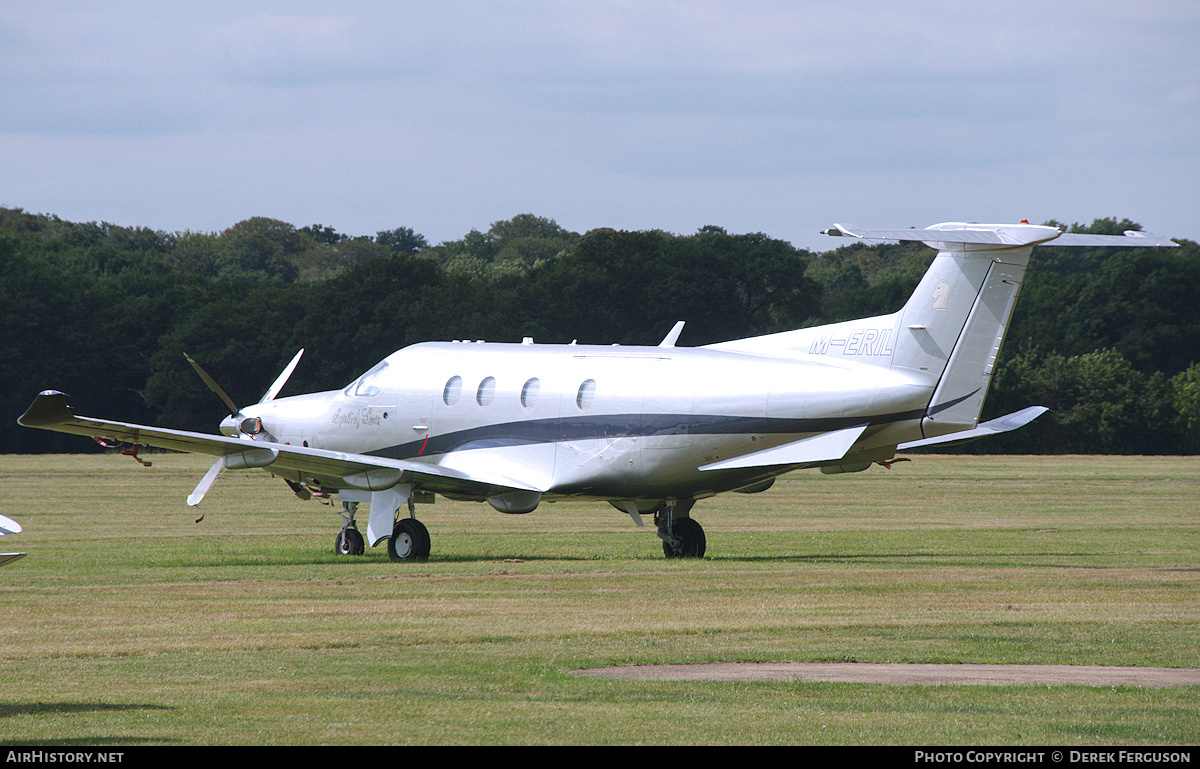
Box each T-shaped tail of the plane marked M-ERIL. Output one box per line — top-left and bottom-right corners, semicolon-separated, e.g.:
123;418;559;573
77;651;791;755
709;222;1176;439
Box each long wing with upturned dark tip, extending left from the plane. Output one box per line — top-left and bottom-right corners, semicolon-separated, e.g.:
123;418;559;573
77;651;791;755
17;390;545;497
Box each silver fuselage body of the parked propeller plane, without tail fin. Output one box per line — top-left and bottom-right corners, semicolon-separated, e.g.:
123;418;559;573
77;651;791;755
231;342;932;500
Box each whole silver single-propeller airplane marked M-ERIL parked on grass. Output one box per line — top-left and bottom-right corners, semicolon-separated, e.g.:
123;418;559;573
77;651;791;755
18;222;1175;560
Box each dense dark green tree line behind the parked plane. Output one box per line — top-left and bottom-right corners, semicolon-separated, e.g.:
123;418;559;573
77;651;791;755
0;209;1200;453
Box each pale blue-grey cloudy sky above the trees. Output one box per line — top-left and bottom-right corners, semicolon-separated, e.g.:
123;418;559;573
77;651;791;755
0;0;1200;251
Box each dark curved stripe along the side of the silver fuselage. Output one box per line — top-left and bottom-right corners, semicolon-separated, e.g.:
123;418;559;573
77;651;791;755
367;409;924;459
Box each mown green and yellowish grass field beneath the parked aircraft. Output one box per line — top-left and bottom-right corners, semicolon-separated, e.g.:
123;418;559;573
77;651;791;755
0;455;1200;745
